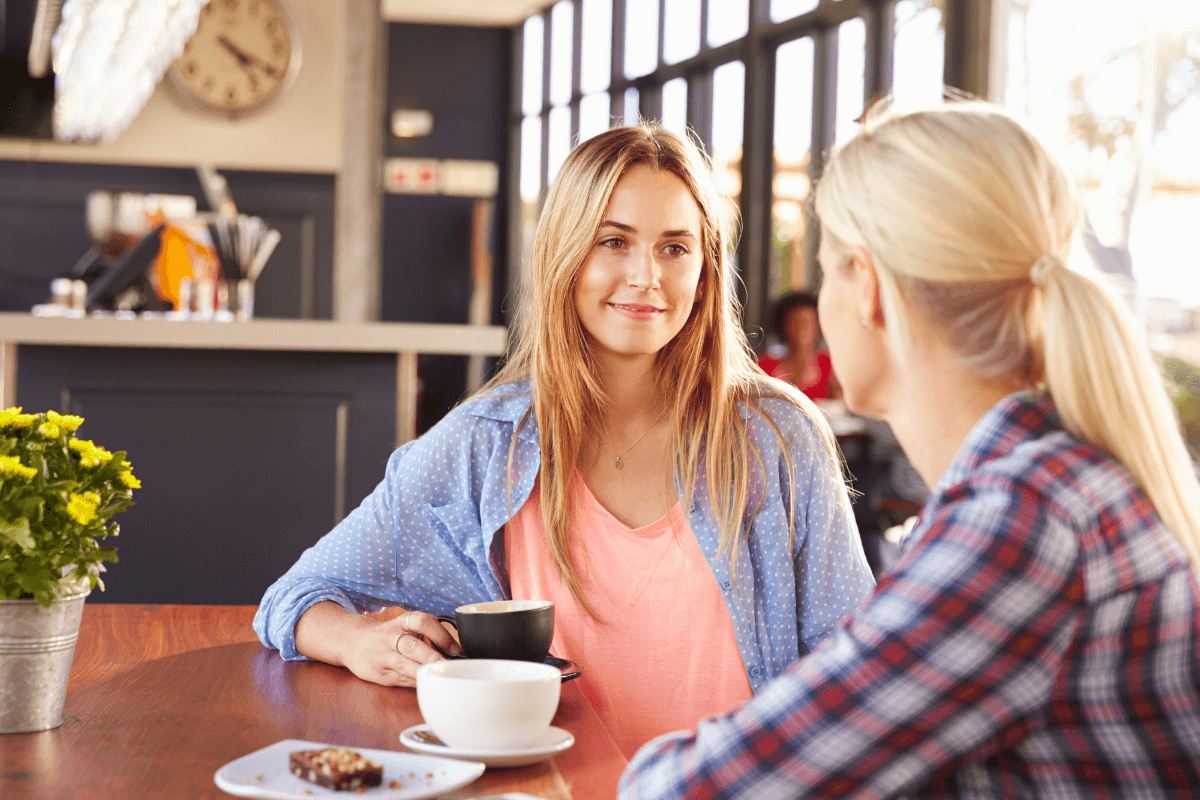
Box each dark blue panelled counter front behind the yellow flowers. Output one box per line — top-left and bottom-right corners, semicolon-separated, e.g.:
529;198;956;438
17;345;396;604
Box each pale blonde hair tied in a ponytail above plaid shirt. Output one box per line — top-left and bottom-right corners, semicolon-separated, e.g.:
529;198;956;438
816;102;1200;564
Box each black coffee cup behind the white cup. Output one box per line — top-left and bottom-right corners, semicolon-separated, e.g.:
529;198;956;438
438;600;554;662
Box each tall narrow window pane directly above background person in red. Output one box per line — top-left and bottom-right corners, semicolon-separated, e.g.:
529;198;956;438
767;37;814;297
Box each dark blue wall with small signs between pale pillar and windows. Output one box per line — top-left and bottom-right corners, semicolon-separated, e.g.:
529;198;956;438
380;23;512;431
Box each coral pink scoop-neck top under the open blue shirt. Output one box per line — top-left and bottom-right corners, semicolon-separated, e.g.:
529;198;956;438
504;474;754;757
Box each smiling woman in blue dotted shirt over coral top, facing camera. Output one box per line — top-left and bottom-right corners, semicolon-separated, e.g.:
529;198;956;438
254;127;872;753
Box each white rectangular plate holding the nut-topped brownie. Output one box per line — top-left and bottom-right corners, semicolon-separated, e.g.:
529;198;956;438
212;739;485;800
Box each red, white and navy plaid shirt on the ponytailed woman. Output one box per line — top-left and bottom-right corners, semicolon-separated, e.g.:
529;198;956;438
620;393;1200;800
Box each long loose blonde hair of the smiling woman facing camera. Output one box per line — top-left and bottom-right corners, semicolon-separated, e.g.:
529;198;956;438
481;125;840;610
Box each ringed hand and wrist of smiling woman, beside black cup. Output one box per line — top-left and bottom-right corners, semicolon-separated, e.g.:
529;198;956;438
295;601;462;686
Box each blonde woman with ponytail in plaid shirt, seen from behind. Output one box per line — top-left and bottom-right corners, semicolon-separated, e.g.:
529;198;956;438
620;102;1200;800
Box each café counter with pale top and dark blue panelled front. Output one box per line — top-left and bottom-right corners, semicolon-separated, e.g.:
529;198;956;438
0;313;505;604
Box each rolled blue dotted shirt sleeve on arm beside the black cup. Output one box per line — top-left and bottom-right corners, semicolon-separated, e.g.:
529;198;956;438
253;407;511;660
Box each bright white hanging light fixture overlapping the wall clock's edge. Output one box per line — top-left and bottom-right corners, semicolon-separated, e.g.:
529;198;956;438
48;0;208;142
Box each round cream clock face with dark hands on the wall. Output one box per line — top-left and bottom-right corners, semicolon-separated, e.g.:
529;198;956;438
169;0;300;116
